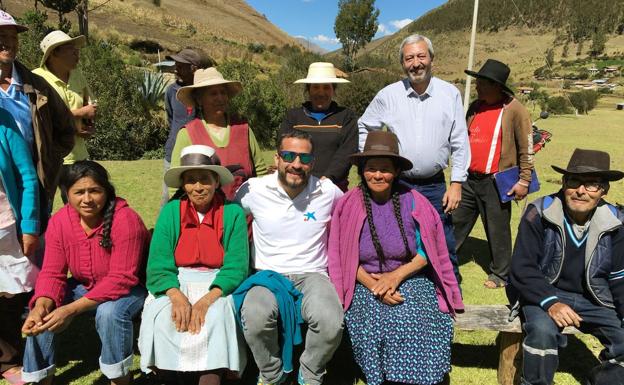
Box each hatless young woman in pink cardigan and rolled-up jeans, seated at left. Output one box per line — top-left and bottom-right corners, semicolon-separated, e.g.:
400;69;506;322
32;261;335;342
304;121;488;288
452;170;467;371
22;161;149;385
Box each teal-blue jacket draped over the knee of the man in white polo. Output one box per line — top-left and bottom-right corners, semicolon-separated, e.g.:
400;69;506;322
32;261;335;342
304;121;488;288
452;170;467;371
232;270;303;373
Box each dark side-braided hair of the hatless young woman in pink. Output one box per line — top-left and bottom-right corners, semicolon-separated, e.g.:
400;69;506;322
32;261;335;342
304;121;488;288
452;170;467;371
60;160;117;249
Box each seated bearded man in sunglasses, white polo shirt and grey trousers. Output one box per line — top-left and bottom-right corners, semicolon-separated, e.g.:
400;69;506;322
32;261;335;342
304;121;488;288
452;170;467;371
236;130;343;385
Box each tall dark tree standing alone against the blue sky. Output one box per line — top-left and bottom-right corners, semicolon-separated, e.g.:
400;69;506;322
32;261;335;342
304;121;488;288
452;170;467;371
334;0;379;70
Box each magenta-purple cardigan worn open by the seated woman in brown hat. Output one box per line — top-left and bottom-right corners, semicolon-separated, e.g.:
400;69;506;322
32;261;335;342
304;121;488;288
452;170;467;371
328;188;464;315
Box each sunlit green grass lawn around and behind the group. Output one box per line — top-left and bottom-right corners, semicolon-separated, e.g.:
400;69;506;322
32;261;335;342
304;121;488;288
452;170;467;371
0;98;624;385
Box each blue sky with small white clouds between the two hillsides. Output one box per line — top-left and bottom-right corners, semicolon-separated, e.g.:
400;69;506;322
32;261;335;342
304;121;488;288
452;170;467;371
247;0;446;51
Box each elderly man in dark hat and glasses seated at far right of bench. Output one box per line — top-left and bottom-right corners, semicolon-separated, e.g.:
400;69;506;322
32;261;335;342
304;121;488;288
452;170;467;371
509;149;624;385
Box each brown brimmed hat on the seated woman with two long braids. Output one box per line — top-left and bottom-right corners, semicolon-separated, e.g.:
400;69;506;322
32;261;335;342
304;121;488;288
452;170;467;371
349;131;413;171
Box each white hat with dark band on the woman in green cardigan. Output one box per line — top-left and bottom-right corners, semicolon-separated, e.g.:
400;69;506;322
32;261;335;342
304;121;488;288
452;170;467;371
165;144;234;188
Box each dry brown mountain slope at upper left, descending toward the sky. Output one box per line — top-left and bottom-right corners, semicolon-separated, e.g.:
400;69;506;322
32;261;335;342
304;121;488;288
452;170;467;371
3;0;301;60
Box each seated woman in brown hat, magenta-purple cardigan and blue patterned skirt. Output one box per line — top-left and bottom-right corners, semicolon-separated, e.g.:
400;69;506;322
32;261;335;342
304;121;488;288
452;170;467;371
329;131;463;385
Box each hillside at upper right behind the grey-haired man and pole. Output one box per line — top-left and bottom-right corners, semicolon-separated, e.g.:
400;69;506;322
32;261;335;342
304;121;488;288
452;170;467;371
352;0;624;81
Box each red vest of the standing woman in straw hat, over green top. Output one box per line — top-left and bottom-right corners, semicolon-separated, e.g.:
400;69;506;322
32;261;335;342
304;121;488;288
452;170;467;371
185;119;254;200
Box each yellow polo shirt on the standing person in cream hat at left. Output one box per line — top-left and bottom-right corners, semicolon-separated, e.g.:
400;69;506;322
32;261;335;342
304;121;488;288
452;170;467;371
33;64;91;164
